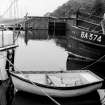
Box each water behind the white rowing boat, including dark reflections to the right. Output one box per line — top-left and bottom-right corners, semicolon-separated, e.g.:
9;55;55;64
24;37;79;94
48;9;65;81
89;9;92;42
15;30;104;74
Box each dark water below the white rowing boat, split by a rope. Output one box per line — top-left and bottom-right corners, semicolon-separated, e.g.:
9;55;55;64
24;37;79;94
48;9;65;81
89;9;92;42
14;91;101;105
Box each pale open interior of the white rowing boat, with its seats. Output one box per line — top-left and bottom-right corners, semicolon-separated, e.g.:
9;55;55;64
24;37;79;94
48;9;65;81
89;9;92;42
11;72;102;87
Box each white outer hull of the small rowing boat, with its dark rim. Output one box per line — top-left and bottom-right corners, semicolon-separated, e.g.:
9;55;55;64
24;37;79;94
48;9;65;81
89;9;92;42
11;70;102;97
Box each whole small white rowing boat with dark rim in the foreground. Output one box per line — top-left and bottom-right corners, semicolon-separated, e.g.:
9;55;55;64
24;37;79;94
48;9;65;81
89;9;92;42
10;70;103;97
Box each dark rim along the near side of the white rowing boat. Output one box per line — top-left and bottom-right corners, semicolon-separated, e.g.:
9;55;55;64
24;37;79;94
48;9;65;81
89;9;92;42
10;70;104;90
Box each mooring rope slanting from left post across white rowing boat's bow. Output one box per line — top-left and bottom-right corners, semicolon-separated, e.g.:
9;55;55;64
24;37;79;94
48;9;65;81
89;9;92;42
2;55;61;105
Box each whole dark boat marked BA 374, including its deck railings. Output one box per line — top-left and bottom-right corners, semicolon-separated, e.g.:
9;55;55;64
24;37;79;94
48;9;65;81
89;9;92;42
67;12;105;60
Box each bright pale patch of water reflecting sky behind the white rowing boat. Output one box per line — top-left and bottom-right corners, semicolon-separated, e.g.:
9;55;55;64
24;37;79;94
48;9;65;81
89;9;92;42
15;32;68;70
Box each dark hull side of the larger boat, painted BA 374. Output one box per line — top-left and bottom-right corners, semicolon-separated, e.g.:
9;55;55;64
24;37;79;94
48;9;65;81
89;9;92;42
67;26;105;59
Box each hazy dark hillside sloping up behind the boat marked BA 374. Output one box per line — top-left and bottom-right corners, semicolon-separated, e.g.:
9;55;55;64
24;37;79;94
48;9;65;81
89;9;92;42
46;0;105;17
